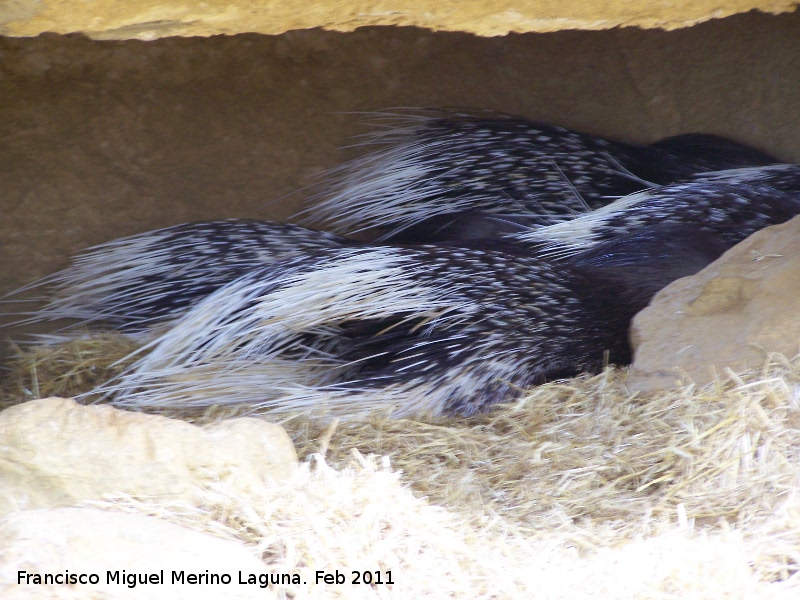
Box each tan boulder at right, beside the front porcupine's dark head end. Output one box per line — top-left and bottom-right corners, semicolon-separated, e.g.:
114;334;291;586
628;217;800;391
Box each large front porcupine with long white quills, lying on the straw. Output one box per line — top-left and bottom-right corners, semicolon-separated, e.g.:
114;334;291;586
94;225;724;416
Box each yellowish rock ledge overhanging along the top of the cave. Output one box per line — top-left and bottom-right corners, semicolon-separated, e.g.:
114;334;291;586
0;0;795;40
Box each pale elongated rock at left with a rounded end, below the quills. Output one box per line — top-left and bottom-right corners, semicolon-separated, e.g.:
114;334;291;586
0;398;297;515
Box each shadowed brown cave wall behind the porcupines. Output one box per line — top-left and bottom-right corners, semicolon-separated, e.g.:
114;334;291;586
0;12;800;318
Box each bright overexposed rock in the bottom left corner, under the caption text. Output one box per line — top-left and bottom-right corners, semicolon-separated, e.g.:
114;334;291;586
0;508;274;600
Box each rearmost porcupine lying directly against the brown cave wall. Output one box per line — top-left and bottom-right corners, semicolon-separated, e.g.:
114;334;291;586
304;110;779;243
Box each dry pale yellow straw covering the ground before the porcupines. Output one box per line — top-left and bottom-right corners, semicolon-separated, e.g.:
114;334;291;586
1;340;800;600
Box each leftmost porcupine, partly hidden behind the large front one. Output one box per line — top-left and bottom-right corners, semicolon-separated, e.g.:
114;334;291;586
10;219;349;332
